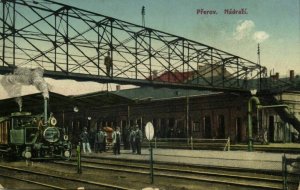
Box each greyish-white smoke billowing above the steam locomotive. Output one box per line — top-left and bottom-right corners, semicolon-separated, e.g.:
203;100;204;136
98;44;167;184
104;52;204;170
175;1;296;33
1;67;49;111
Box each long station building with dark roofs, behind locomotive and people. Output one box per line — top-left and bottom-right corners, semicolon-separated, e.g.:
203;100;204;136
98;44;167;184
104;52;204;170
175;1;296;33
0;73;300;144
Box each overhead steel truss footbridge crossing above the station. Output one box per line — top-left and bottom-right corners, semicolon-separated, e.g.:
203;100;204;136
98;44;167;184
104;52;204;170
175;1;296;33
0;0;266;92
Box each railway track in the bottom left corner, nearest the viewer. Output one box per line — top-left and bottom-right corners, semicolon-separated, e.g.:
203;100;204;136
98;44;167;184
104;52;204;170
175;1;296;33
0;165;132;190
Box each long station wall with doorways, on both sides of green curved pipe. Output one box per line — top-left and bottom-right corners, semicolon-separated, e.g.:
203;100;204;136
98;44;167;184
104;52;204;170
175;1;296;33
49;91;300;143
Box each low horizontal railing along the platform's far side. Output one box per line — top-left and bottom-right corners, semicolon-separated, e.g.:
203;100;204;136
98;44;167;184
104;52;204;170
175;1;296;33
154;137;230;151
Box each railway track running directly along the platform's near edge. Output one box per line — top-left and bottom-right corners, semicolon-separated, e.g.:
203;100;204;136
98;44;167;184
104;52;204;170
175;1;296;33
55;157;283;189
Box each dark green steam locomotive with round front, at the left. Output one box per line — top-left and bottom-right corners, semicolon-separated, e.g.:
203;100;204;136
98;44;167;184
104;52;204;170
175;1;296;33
0;99;72;159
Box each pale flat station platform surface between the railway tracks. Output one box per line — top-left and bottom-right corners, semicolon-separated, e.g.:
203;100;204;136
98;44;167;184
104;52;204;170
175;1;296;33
83;148;300;172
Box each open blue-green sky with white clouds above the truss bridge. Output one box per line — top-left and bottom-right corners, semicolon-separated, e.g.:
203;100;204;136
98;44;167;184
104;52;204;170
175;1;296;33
51;0;300;74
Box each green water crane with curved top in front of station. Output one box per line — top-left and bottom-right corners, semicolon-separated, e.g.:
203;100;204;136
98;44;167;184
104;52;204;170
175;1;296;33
248;89;260;152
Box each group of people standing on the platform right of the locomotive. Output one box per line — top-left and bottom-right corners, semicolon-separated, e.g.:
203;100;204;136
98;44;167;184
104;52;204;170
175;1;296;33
80;125;143;155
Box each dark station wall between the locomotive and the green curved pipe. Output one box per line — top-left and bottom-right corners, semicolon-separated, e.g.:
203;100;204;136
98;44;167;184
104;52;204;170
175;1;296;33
63;94;251;142
